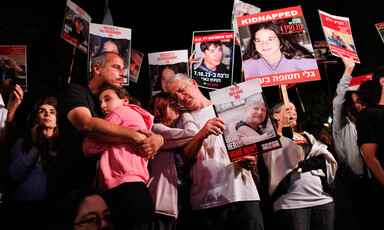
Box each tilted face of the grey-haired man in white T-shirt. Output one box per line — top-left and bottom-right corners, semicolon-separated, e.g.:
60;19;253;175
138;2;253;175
168;80;199;111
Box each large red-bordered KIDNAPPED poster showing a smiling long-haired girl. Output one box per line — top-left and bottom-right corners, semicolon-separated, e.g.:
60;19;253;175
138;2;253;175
237;6;320;87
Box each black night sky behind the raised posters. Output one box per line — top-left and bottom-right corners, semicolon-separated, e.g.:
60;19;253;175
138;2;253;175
0;0;384;129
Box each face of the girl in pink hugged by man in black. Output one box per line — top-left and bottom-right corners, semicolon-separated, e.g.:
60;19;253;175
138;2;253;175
99;89;129;116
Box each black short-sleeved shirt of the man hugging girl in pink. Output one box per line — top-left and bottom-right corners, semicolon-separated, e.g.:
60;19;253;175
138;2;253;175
56;83;102;195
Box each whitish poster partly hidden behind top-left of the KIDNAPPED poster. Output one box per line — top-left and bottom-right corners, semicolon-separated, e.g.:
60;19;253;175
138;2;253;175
232;0;260;45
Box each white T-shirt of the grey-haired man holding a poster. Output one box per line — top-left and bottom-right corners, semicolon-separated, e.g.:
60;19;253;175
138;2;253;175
190;106;260;210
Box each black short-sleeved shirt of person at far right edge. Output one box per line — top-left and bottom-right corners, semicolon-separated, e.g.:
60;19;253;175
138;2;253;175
356;105;384;166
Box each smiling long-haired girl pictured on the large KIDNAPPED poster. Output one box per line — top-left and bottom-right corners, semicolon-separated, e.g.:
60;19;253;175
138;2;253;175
243;22;317;80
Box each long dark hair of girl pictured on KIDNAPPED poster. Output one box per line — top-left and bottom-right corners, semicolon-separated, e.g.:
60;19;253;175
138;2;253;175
244;22;315;60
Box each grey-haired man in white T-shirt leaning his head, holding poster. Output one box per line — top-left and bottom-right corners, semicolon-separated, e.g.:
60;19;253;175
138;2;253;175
167;74;264;229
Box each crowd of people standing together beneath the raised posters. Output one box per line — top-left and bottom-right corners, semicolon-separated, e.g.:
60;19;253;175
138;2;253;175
0;48;384;230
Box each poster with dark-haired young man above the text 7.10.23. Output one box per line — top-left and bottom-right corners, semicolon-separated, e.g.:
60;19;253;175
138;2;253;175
191;30;234;89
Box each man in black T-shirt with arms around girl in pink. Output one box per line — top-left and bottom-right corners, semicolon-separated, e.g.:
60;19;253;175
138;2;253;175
56;52;162;196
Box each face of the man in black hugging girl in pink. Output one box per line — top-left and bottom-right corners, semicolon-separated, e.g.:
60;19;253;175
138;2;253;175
94;53;125;87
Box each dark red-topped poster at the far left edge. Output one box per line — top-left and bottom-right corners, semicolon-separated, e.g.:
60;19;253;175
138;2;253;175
0;45;27;92
